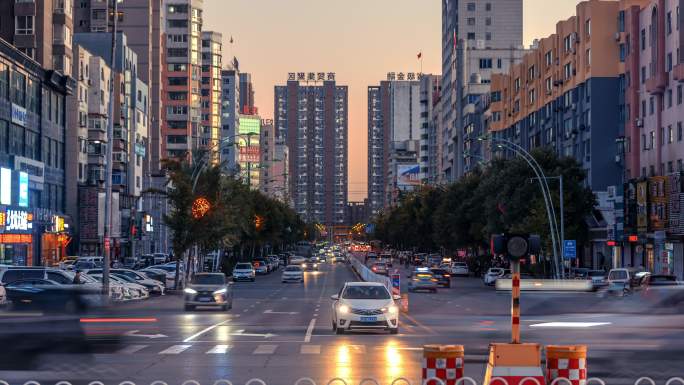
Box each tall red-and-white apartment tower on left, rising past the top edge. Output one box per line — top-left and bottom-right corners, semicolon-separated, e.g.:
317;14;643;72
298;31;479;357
161;0;203;158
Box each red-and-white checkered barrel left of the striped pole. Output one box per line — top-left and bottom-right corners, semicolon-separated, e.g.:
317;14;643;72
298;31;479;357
422;345;464;385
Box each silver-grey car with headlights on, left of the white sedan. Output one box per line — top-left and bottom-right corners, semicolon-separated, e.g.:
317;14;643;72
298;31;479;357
184;273;233;311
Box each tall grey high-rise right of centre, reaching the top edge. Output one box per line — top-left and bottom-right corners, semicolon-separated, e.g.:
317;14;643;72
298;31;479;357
441;0;524;181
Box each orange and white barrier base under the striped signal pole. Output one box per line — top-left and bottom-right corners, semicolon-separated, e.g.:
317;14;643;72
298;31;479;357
483;344;545;385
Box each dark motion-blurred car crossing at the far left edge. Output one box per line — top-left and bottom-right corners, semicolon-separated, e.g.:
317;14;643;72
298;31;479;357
5;278;105;314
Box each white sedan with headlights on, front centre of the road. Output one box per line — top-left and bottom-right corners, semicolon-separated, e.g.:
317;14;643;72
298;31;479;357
330;282;400;334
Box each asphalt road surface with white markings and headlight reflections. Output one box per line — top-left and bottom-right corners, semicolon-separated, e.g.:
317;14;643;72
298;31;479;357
0;258;684;385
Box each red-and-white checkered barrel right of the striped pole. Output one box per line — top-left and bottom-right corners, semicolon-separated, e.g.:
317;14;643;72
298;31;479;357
546;345;587;385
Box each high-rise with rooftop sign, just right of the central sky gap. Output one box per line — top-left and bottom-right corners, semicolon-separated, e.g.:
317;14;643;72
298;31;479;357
368;80;421;215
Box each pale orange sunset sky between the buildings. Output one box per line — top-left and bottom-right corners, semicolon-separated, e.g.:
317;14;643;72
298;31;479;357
203;0;579;200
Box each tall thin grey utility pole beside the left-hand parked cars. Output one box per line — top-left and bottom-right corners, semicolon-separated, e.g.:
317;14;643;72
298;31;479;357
102;0;119;297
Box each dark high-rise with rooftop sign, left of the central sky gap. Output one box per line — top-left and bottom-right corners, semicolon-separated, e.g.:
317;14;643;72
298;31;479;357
274;73;348;225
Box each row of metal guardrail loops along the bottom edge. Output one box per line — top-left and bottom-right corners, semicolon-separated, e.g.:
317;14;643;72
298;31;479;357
0;377;684;385
